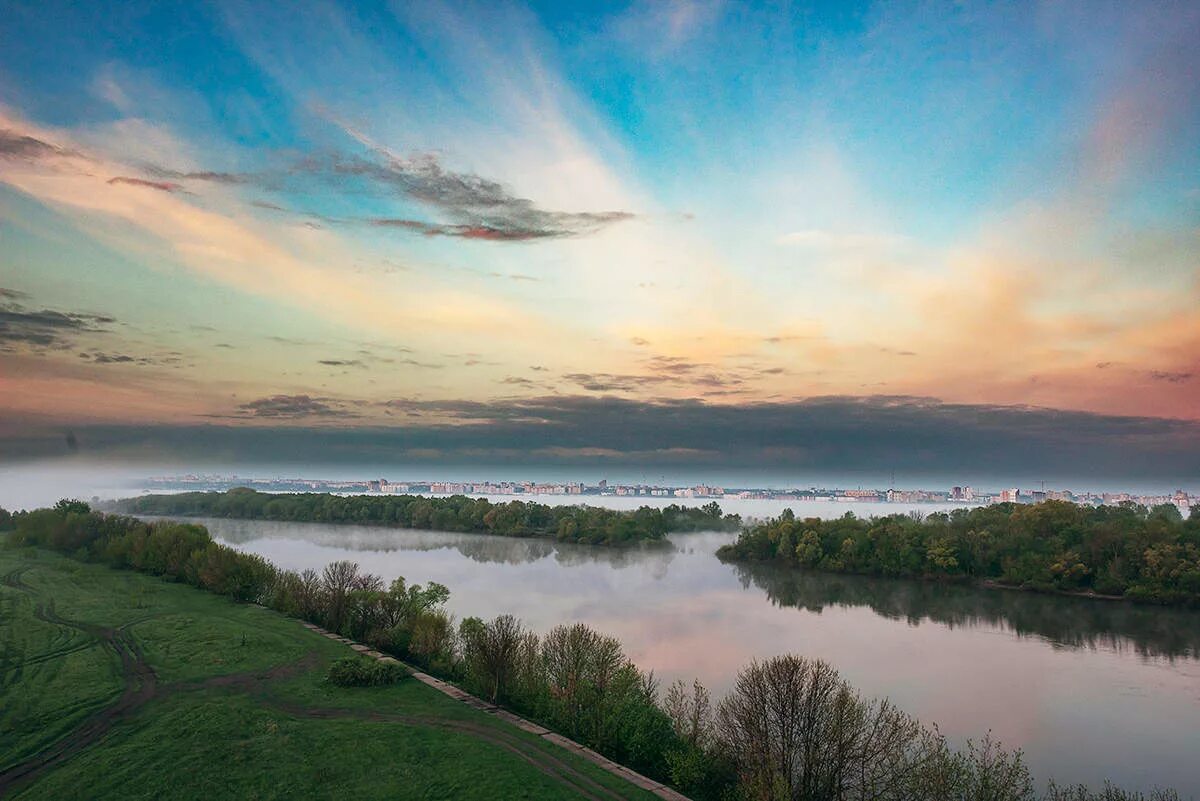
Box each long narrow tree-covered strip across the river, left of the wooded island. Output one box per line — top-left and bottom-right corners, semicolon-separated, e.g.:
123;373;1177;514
116;488;742;546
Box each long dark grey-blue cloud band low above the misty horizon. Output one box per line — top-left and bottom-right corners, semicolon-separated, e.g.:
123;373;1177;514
9;395;1200;486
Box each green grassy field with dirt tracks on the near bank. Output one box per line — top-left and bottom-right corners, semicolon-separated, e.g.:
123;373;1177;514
0;542;653;801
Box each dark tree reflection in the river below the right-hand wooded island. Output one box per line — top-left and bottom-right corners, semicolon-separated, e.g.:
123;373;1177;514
732;565;1200;660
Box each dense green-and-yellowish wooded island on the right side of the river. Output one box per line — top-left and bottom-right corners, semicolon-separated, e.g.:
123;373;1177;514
718;501;1200;607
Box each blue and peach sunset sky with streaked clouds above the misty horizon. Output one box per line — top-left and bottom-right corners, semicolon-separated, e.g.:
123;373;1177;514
0;0;1200;481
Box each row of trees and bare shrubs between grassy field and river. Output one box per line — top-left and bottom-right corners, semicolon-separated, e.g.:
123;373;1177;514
0;501;1178;801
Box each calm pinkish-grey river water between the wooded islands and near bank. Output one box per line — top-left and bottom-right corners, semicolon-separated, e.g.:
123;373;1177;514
189;508;1200;799
